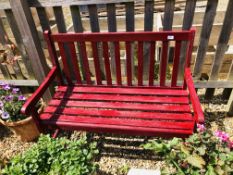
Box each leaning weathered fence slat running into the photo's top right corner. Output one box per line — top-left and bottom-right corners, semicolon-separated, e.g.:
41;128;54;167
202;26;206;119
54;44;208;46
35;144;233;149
205;1;233;99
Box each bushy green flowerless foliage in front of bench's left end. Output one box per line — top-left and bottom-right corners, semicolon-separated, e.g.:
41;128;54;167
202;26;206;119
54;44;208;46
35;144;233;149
3;135;98;175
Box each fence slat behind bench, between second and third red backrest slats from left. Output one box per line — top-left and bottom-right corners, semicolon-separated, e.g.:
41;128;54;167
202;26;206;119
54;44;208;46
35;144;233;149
70;6;86;80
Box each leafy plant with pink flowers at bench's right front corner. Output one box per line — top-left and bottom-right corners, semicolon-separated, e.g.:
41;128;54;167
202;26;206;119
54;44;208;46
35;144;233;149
143;125;233;175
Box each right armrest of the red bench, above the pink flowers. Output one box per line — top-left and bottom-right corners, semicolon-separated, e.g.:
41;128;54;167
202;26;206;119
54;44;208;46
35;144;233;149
184;68;204;123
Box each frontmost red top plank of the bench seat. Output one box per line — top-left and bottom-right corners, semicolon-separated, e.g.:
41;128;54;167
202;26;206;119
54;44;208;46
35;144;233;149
40;114;194;130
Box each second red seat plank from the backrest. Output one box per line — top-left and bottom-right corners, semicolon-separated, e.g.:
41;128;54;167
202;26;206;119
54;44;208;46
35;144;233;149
53;92;189;104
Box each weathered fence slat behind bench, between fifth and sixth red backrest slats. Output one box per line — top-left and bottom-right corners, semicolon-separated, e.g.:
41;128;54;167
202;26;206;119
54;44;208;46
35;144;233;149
107;4;117;76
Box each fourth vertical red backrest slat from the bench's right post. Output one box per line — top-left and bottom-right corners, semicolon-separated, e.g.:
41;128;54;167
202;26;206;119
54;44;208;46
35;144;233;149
138;41;143;86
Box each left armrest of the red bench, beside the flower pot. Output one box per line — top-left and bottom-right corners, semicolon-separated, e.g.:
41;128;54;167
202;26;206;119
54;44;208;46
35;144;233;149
21;66;58;115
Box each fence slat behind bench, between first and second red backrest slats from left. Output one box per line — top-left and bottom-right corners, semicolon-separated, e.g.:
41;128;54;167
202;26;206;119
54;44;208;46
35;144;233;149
53;6;76;80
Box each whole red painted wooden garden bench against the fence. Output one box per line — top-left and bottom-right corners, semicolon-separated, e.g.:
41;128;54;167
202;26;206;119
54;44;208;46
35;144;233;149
22;29;204;137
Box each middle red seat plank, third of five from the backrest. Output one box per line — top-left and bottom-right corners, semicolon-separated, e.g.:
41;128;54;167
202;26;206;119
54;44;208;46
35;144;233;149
49;99;191;113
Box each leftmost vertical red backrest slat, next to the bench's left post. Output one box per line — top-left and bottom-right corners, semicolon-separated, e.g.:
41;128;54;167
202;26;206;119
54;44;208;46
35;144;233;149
58;42;73;85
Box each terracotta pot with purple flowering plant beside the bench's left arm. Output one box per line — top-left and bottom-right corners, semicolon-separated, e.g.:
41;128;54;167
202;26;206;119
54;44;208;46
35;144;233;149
0;82;42;141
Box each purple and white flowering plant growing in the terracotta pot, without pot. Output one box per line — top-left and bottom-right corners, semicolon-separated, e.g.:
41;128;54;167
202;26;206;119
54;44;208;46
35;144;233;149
0;82;27;122
